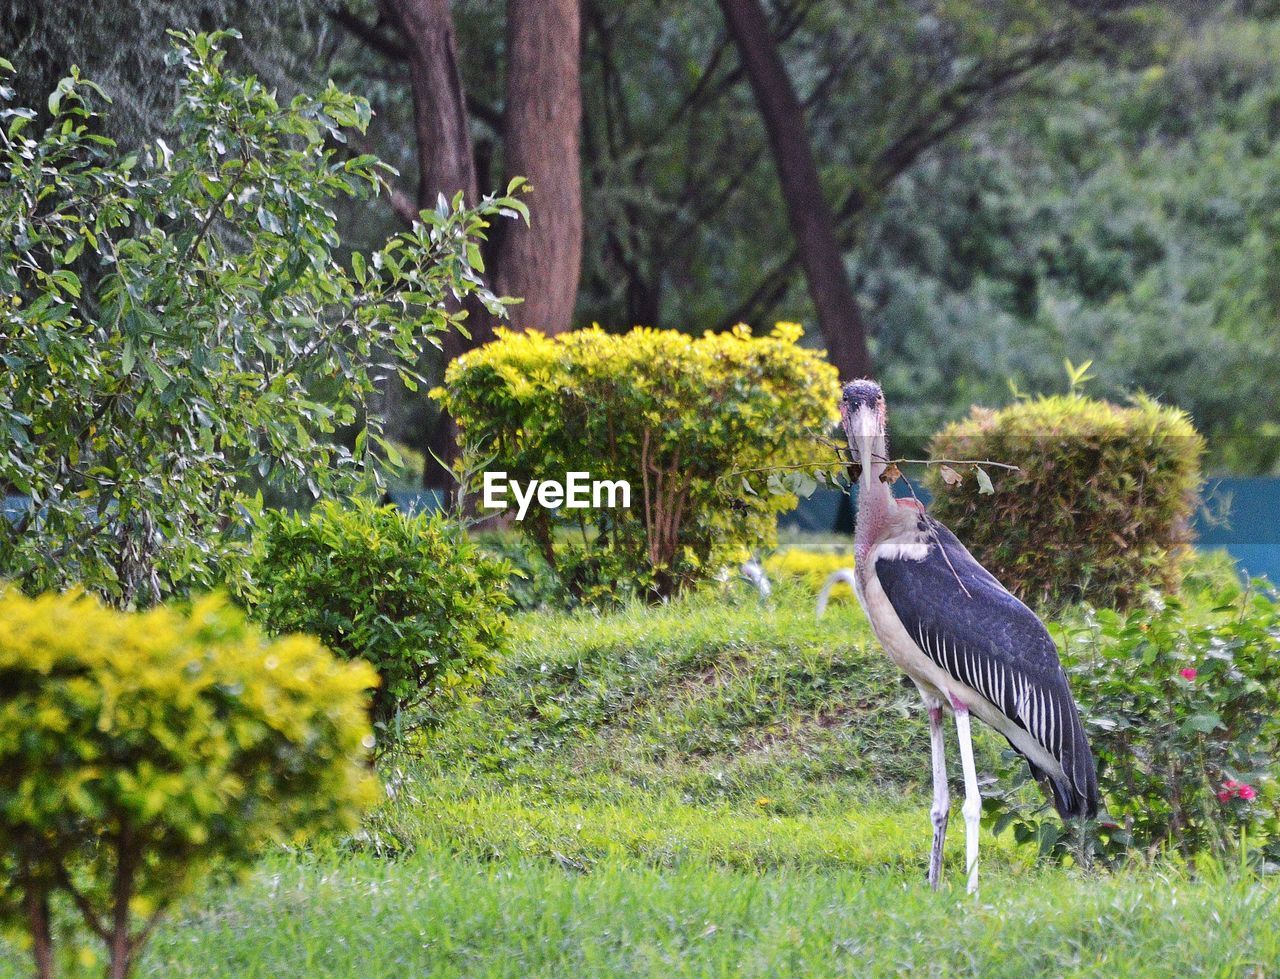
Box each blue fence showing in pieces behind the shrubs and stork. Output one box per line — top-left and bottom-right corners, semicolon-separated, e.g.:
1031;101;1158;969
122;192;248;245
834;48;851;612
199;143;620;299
4;477;1280;584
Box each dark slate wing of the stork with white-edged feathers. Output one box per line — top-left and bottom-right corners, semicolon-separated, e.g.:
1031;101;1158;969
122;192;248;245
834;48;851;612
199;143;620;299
876;516;1098;819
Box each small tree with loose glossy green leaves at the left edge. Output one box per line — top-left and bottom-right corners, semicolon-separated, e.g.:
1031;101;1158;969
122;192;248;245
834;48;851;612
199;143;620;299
0;32;524;607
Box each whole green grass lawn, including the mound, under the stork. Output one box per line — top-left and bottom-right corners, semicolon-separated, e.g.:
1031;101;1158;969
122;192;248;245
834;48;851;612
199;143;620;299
0;573;1280;978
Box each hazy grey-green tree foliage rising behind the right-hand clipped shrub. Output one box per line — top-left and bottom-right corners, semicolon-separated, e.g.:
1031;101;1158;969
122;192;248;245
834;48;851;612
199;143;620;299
850;17;1280;472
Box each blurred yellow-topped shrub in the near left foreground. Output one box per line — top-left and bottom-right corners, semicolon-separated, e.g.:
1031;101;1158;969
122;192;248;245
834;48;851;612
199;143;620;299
0;590;378;975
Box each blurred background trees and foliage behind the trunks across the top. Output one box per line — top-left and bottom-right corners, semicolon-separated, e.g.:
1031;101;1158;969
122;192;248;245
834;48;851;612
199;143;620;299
0;0;1280;474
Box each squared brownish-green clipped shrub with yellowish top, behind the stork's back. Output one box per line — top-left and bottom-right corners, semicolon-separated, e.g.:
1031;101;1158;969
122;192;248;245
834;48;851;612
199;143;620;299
929;394;1204;607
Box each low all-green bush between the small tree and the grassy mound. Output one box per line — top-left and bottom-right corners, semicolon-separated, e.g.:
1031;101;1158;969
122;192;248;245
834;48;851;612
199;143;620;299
242;502;511;744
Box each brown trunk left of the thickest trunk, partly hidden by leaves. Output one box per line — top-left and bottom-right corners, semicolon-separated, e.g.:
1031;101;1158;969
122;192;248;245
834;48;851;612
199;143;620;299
383;0;493;489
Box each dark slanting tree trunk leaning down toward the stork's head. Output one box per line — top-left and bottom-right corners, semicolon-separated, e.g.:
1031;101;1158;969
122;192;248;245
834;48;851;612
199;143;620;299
719;0;872;380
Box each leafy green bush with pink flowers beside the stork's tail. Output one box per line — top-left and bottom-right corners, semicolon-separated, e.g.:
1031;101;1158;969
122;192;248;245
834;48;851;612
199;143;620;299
988;585;1280;860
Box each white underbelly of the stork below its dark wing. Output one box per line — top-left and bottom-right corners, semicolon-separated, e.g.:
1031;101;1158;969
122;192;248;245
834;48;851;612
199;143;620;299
855;573;1062;777
